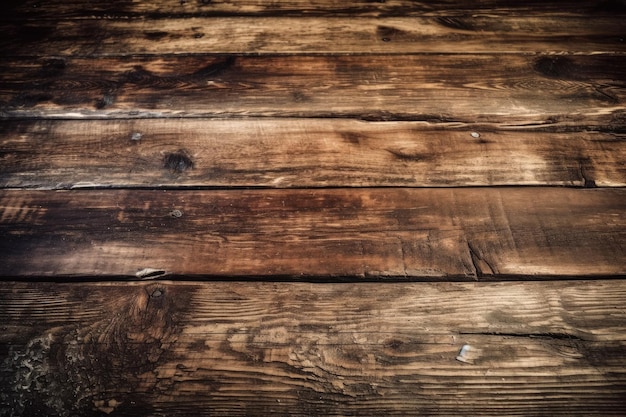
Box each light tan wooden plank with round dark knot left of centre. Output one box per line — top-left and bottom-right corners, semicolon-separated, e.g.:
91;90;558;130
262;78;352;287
0;119;626;189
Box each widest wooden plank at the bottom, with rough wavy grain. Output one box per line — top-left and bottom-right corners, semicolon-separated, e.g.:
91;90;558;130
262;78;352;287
0;281;626;416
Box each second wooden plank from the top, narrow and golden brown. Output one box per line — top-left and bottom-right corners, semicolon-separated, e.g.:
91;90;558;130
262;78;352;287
0;16;626;57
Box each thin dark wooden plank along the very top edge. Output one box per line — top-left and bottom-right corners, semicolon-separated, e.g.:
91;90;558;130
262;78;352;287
3;0;626;20
